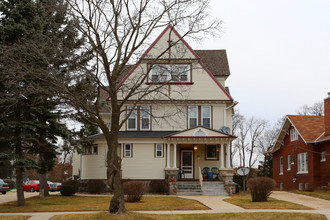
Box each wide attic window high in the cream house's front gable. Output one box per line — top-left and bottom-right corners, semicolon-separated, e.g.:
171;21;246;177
149;64;191;83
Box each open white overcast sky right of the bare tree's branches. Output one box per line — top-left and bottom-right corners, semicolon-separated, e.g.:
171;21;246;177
191;0;330;123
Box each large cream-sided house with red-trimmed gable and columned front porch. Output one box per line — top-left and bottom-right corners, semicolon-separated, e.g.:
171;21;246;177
73;26;237;192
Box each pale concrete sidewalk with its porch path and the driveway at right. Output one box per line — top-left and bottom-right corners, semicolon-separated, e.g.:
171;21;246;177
0;191;330;220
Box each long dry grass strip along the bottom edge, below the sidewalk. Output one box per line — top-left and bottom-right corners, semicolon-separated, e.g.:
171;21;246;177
51;212;326;220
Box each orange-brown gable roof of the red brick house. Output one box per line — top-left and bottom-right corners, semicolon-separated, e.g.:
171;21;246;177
272;115;330;152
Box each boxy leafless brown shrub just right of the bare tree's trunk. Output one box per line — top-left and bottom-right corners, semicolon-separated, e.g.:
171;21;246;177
123;181;146;202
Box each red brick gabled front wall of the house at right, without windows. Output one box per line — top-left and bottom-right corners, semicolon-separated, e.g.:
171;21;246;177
273;125;320;189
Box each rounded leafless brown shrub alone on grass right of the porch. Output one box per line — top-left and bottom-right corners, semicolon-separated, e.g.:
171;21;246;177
247;177;275;202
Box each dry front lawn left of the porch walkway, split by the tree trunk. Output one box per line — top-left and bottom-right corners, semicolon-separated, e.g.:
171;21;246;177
0;196;209;212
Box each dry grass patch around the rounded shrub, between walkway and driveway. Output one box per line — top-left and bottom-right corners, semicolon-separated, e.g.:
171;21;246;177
224;192;312;210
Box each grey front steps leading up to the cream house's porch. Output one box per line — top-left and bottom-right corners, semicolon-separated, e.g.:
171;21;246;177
177;181;228;196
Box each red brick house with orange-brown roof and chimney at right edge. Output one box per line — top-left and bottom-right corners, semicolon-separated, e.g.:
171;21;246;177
272;93;330;190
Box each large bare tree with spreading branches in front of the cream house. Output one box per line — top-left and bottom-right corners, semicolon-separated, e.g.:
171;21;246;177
64;0;220;214
